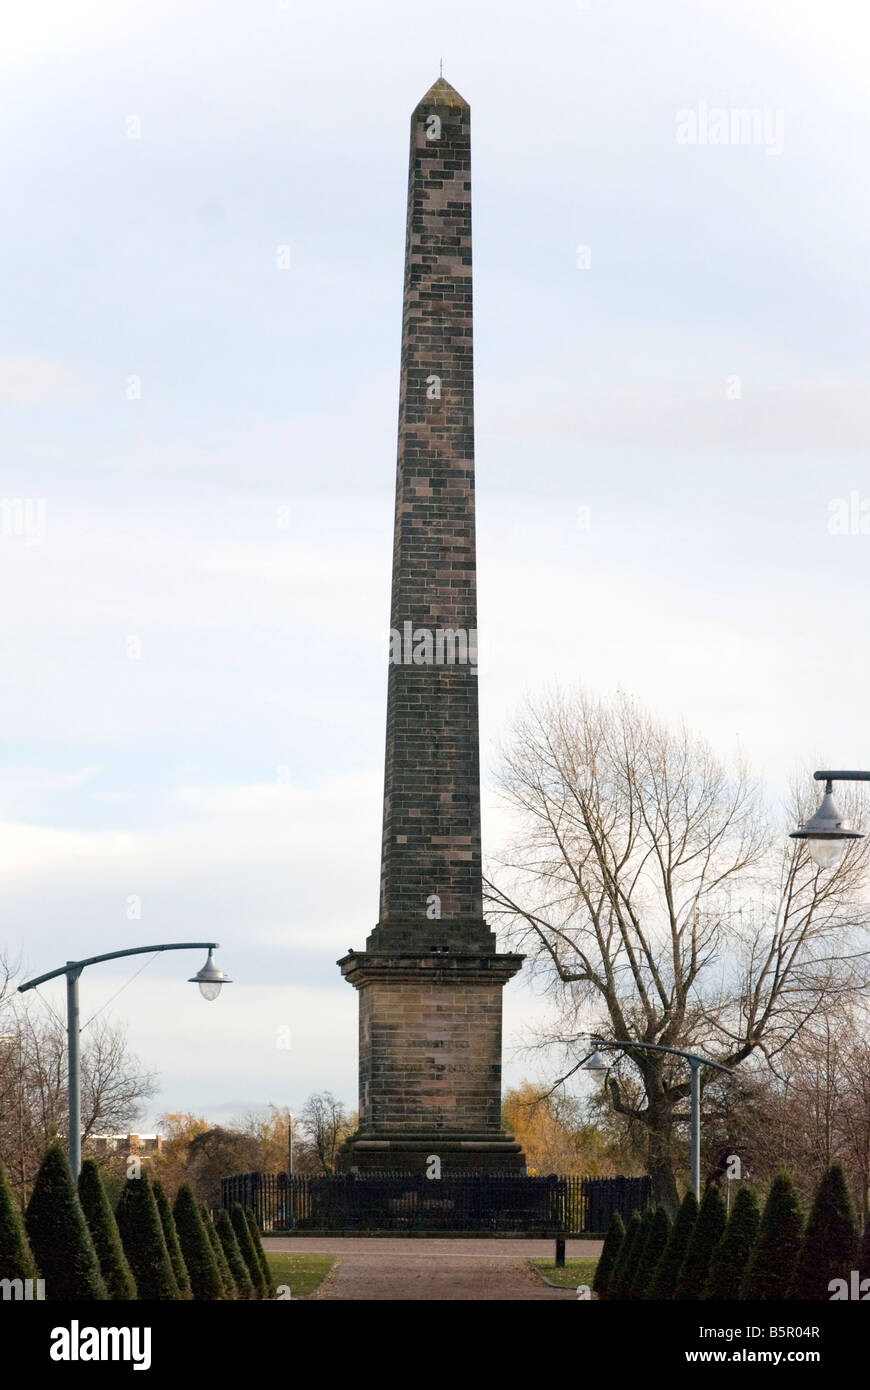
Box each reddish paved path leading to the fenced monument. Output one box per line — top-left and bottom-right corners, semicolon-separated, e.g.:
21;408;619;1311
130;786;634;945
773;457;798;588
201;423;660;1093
263;1236;602;1301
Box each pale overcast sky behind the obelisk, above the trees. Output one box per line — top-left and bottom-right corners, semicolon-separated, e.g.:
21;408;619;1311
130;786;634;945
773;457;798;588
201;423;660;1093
0;0;870;1123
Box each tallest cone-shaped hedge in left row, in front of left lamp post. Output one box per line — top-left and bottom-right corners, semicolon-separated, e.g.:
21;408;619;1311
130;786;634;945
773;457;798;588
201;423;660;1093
25;1144;107;1302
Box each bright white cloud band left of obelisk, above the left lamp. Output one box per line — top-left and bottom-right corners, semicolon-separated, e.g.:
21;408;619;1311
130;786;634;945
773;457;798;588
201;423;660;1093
0;769;381;961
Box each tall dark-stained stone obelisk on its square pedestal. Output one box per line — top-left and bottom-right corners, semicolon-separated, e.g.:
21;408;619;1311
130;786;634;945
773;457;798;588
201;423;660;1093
339;78;525;1173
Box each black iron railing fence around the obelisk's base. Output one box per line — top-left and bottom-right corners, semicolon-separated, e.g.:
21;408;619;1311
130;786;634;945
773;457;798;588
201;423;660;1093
221;1173;650;1236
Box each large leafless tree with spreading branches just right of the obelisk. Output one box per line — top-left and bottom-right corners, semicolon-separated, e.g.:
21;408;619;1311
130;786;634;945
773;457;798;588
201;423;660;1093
486;692;870;1205
